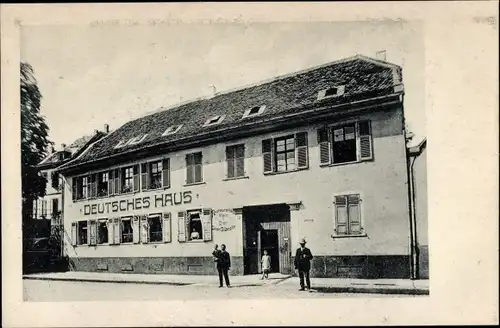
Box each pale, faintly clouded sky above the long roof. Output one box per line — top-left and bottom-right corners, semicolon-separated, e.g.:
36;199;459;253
21;21;426;149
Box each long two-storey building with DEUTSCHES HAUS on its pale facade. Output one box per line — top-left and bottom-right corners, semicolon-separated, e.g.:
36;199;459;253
59;55;426;278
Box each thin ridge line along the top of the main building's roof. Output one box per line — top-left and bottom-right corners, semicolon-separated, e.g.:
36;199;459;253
131;53;388;123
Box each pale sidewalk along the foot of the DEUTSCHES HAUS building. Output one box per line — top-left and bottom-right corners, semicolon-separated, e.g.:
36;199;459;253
23;271;429;295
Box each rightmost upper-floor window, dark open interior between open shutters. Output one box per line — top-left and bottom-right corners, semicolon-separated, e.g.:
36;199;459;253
318;121;373;165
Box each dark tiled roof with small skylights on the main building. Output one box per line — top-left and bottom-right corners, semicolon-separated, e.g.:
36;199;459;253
60;55;402;166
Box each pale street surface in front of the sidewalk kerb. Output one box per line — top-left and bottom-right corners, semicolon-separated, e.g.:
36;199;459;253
23;280;422;302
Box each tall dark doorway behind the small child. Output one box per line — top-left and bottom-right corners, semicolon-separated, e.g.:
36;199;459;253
243;204;293;274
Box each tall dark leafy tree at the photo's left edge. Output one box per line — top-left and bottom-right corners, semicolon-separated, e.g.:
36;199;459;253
21;63;53;221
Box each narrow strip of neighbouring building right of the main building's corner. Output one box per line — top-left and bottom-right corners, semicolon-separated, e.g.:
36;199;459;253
408;139;429;279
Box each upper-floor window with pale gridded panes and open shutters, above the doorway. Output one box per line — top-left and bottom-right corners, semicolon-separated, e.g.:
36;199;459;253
262;132;309;173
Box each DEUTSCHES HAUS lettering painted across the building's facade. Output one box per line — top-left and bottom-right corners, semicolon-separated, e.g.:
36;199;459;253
83;191;193;215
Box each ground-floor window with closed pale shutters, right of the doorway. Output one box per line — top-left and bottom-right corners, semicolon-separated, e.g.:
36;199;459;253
334;194;364;236
